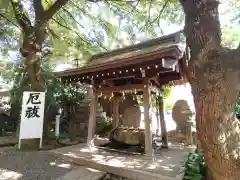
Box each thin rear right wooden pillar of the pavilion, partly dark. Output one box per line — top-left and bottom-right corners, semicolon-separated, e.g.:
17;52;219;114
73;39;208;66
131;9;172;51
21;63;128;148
159;93;168;148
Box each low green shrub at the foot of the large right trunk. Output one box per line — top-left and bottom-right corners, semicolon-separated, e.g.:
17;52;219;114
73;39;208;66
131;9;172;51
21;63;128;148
183;153;207;180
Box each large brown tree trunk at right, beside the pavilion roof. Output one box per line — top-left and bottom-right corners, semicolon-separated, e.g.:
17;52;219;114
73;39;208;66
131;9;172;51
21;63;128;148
180;0;240;180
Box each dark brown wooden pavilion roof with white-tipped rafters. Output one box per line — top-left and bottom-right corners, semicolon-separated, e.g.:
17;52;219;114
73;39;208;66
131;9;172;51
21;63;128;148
57;32;188;86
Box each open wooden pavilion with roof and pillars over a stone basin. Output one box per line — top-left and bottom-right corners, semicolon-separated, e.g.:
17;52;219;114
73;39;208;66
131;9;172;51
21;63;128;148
55;32;188;156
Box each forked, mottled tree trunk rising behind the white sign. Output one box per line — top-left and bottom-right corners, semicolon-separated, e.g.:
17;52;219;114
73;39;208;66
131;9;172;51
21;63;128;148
10;0;69;138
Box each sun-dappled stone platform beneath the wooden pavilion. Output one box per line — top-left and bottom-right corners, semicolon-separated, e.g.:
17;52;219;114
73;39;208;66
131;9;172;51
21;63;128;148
51;144;191;180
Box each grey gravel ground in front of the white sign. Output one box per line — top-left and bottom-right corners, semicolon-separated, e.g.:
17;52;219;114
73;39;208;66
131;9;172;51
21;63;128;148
0;148;74;180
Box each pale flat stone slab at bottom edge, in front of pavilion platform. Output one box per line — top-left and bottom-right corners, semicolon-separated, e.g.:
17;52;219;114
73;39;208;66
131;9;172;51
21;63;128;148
60;166;106;180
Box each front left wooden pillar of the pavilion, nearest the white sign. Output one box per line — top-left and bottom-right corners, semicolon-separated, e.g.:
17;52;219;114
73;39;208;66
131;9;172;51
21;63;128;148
87;81;97;146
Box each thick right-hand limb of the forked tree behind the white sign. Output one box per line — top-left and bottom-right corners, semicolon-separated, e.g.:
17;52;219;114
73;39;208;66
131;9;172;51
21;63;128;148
42;0;70;22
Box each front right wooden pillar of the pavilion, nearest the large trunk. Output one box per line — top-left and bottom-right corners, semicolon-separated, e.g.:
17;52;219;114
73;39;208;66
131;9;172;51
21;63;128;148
143;74;153;157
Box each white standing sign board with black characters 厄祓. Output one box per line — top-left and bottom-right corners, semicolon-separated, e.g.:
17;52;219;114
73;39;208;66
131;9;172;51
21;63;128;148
18;91;45;149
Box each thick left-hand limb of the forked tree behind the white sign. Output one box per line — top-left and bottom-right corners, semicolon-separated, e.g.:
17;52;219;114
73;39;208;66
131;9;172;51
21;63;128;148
10;0;32;32
